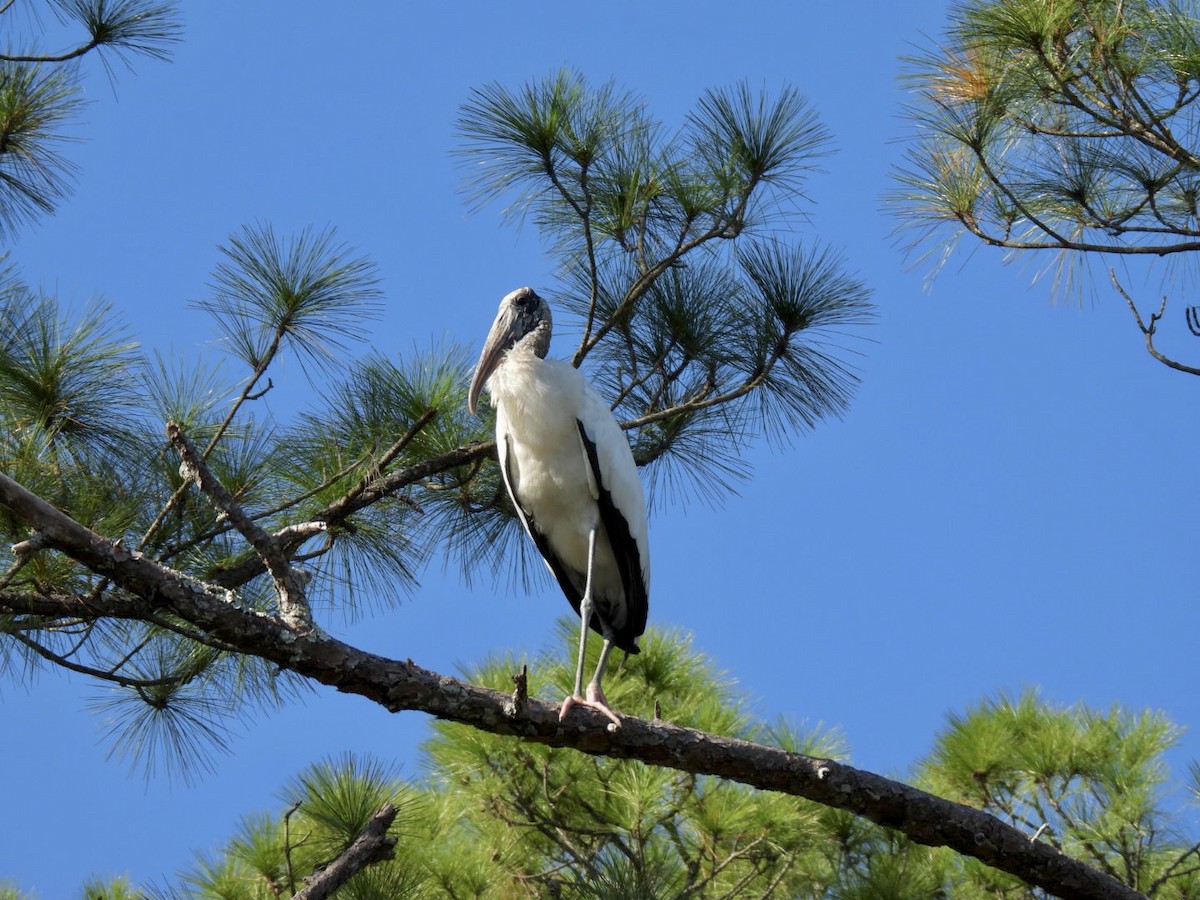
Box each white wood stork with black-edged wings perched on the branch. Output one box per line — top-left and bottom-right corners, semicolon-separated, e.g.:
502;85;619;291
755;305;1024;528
467;288;650;727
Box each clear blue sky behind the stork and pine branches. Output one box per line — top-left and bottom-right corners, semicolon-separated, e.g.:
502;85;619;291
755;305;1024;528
0;0;1200;899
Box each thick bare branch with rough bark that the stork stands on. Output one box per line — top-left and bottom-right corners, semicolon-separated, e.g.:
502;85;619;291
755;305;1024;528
0;474;1141;900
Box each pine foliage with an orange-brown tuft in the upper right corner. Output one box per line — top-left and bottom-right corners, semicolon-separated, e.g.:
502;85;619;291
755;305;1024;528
893;0;1200;374
